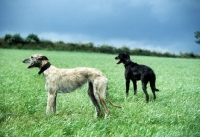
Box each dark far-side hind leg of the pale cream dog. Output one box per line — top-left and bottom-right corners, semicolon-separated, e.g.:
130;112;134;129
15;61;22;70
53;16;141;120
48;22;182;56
88;82;101;117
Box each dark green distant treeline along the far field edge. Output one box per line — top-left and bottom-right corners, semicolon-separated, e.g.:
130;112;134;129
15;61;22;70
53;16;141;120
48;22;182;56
0;34;200;58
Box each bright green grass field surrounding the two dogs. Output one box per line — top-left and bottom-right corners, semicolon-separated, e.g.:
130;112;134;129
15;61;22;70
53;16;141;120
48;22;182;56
0;49;200;137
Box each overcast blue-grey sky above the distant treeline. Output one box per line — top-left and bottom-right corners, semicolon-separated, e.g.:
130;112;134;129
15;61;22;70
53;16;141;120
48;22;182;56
0;0;200;54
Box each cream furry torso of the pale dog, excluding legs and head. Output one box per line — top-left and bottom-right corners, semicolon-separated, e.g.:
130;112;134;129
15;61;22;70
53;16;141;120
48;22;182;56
44;66;107;93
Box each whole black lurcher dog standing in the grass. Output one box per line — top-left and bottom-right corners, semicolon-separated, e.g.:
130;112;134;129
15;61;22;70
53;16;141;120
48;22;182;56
115;53;159;102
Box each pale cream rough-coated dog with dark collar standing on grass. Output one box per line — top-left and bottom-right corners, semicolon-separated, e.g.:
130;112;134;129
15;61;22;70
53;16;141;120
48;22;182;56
23;54;121;118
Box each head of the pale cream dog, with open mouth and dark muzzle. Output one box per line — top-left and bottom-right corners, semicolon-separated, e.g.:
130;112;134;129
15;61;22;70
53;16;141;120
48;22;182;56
22;54;48;68
